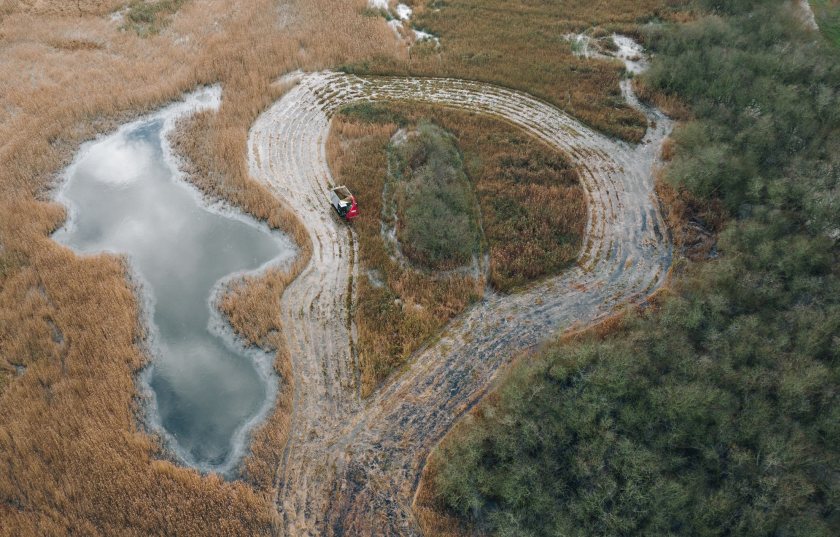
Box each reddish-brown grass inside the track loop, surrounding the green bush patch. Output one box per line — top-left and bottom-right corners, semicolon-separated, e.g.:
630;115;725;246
327;103;586;395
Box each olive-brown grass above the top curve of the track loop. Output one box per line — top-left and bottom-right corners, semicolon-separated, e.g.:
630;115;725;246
350;0;682;141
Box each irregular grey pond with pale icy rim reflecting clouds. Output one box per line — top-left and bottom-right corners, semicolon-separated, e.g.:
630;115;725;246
53;87;296;473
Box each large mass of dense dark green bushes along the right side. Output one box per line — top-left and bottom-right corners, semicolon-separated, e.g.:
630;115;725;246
433;1;840;536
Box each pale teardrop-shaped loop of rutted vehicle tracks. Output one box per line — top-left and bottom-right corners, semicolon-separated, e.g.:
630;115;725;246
249;60;672;535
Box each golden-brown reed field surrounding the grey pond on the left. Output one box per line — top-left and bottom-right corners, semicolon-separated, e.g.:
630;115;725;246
0;0;400;535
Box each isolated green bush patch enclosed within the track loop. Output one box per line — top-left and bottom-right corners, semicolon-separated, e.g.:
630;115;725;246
390;121;481;269
